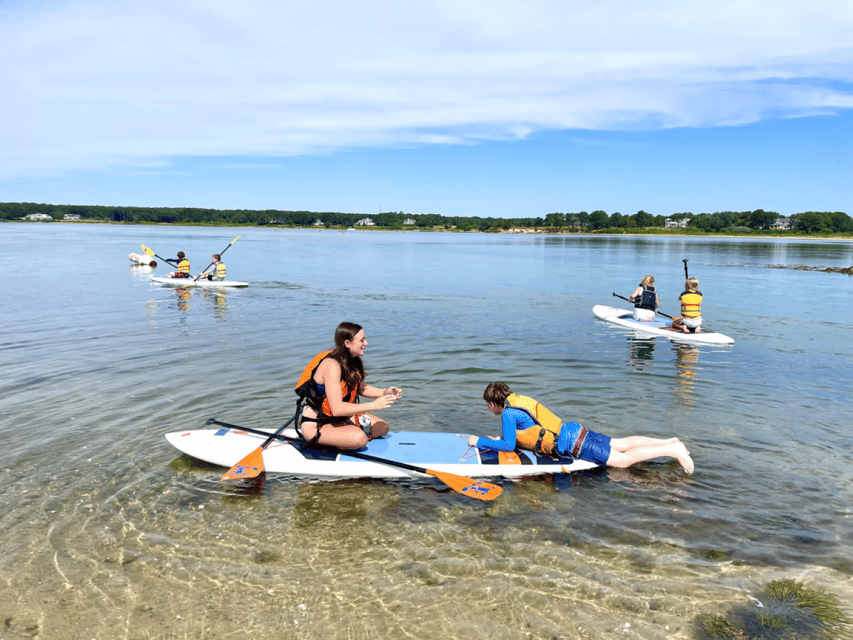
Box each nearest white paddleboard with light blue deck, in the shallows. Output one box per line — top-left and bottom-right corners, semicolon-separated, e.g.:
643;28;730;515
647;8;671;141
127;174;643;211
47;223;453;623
166;427;598;478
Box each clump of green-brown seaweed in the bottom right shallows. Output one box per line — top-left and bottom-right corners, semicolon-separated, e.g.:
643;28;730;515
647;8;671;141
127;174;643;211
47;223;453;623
698;579;853;640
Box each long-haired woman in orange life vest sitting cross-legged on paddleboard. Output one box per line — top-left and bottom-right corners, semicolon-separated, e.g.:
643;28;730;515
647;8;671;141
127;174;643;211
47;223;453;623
296;322;403;449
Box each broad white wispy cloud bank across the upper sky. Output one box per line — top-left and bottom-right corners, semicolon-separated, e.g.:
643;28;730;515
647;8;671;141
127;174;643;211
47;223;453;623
0;0;853;179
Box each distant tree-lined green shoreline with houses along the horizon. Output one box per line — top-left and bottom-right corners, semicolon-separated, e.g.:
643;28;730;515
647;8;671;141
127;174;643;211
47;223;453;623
0;202;853;237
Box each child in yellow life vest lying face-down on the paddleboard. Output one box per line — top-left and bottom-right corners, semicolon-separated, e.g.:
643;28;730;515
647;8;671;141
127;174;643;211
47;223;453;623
468;382;693;473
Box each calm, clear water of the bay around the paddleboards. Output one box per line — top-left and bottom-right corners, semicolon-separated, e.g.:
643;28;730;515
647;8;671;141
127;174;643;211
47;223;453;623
0;223;853;640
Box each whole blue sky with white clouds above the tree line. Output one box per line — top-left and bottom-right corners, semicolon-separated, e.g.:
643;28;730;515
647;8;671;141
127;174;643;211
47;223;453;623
0;0;853;217
